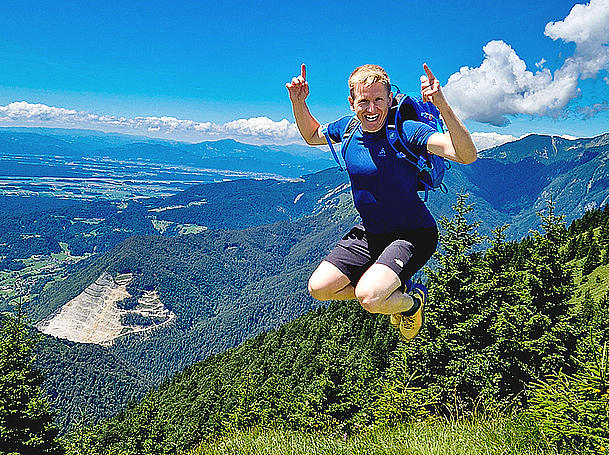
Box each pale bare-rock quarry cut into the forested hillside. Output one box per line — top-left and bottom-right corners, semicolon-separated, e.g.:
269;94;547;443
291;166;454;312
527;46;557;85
37;272;175;346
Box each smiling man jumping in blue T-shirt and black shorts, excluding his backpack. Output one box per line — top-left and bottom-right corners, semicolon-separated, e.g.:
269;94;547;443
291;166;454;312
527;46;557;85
286;64;477;340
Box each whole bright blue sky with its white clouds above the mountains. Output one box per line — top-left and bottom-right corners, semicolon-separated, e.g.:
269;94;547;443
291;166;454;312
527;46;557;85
0;0;609;147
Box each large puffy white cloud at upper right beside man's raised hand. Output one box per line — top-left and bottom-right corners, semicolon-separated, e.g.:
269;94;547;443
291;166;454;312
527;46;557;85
445;0;609;126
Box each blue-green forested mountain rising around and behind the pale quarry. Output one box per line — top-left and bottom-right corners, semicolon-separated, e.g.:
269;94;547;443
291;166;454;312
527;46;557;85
30;195;354;432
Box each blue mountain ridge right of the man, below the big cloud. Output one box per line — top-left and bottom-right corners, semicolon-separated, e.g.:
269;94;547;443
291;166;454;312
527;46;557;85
428;134;609;239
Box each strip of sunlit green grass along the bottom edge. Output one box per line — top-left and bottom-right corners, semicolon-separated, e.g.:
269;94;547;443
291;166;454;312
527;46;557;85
188;417;556;455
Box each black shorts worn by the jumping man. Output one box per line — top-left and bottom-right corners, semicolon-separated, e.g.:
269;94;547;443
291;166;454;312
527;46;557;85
326;225;438;287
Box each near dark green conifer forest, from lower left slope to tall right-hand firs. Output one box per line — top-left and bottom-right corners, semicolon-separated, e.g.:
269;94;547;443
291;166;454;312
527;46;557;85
63;196;609;454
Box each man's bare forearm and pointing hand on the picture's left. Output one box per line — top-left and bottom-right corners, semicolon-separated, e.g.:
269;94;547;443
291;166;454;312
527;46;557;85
285;63;326;145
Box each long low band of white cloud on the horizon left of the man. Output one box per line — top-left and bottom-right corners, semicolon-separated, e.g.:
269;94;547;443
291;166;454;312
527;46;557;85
0;101;302;143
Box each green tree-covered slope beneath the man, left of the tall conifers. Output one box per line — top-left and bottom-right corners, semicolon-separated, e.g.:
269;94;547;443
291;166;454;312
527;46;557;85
70;302;398;453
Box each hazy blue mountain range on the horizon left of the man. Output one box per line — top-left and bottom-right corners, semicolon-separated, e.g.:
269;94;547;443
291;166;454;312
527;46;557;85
0;128;332;177
